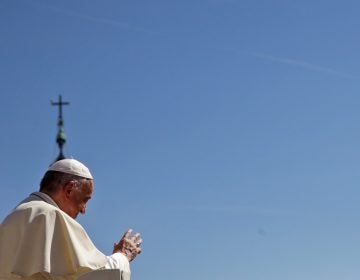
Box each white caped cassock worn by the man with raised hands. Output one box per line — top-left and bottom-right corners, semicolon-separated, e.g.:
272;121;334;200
0;192;130;280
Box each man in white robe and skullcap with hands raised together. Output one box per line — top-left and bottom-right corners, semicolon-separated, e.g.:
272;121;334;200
0;159;142;280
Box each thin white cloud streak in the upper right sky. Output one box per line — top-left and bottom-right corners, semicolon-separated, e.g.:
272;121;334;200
248;52;359;80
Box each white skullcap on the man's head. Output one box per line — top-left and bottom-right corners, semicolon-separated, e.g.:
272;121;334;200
48;158;93;179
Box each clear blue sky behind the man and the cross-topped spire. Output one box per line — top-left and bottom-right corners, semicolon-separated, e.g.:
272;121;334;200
0;0;360;280
